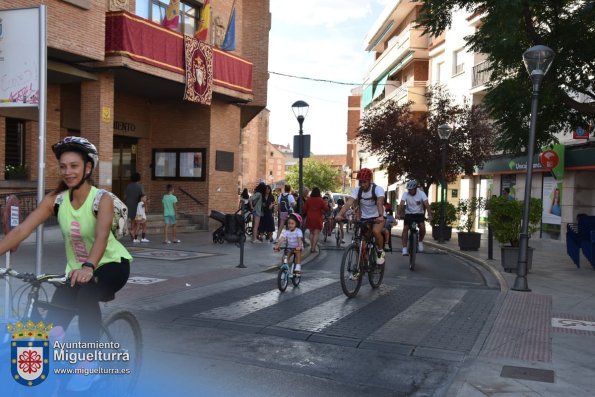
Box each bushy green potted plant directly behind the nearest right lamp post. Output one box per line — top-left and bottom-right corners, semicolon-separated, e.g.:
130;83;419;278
488;197;542;272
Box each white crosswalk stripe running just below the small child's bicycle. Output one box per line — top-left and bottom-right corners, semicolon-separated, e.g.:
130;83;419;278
194;278;338;320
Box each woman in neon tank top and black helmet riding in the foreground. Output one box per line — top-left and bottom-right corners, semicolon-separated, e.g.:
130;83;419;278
0;136;132;391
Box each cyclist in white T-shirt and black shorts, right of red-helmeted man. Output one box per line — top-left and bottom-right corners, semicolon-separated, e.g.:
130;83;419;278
397;180;432;256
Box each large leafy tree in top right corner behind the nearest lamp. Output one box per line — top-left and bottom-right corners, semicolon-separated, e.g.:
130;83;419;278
417;0;595;152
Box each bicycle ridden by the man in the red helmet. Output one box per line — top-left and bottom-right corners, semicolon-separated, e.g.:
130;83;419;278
341;220;384;298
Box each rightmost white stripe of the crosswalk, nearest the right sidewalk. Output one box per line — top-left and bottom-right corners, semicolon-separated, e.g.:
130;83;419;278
368;288;467;345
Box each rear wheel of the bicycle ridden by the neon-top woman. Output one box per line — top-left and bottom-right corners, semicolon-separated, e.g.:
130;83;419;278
101;311;143;396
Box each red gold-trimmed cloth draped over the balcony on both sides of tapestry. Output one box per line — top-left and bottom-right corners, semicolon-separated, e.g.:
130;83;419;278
105;11;253;100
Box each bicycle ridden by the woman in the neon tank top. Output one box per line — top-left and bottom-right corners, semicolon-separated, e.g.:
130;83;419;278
0;268;142;396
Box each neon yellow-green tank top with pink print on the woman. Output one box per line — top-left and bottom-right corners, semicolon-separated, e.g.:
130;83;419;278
58;186;132;275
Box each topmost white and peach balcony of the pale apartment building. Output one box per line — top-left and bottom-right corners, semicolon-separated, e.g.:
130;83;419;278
368;23;428;81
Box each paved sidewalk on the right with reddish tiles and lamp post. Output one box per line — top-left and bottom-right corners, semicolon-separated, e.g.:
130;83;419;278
393;225;595;397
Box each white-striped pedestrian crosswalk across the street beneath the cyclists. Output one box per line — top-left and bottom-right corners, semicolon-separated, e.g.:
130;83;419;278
174;277;499;352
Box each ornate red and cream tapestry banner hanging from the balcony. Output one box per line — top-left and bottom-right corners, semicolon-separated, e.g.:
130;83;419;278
184;36;213;105
